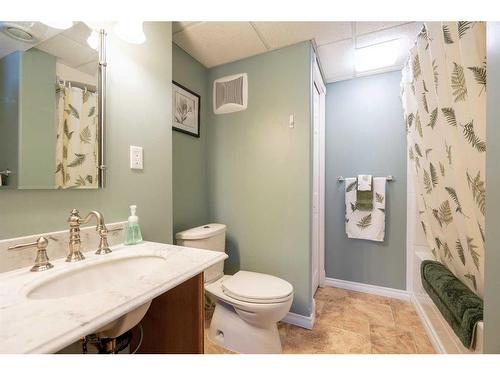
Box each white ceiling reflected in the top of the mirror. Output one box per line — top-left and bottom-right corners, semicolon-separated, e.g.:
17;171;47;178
0;22;99;75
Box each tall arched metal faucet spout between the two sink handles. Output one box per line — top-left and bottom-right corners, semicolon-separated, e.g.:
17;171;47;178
66;208;111;262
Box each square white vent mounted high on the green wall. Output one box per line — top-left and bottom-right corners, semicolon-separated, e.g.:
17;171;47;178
213;73;248;114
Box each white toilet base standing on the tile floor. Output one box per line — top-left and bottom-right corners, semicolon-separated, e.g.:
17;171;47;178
208;300;282;354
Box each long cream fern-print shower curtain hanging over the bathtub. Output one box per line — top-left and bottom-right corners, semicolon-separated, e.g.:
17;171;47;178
401;22;486;296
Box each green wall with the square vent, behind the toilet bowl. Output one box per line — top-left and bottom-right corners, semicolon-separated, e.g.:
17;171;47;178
208;42;312;315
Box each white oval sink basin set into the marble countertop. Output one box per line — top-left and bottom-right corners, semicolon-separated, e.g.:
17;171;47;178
26;255;165;299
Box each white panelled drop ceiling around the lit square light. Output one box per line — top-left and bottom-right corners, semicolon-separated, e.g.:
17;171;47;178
172;21;422;82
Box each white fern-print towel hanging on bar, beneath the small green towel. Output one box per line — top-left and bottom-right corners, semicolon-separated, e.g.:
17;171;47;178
345;177;386;241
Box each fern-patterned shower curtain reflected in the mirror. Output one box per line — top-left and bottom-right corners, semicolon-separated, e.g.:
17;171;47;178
55;87;98;189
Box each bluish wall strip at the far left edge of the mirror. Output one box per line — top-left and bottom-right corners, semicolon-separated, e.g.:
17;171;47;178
0;52;21;189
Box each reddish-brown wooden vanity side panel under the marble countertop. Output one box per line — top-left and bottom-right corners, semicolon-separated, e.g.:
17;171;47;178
131;273;204;354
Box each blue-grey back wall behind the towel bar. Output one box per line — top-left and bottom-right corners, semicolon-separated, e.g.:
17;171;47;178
325;72;406;289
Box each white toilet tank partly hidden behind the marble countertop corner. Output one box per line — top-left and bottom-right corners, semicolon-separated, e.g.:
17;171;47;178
175;223;226;283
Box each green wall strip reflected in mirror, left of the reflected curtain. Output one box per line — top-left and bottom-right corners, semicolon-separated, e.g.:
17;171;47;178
17;48;56;189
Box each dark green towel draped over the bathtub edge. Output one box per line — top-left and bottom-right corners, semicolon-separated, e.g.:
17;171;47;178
420;260;483;349
